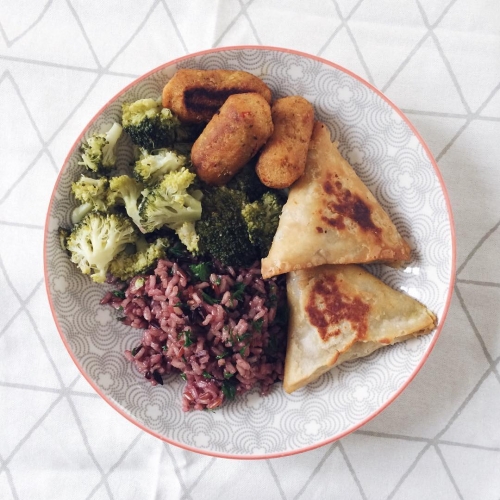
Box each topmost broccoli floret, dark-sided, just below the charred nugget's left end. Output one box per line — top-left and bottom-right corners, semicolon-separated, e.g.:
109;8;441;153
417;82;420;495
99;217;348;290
122;99;180;151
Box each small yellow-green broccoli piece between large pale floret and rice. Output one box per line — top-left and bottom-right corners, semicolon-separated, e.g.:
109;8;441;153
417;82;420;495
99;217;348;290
109;238;170;281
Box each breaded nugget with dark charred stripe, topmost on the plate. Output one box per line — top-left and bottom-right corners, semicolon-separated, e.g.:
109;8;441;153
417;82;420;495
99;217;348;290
162;69;271;123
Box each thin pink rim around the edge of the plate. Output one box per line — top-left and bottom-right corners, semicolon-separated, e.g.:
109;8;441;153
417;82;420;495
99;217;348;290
43;45;456;460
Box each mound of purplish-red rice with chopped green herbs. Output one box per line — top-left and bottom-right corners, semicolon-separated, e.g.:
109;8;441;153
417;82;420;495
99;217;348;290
101;260;286;411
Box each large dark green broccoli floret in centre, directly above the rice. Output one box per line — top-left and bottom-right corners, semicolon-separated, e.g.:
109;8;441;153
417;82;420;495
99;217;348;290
196;186;258;266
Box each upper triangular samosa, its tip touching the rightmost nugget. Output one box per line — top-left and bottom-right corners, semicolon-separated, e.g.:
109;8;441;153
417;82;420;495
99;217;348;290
262;122;410;278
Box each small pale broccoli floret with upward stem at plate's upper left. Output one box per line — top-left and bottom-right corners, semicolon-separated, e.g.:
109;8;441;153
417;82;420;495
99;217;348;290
78;122;122;173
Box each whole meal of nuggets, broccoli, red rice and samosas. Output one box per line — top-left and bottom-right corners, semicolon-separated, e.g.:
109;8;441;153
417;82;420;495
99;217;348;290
60;69;436;411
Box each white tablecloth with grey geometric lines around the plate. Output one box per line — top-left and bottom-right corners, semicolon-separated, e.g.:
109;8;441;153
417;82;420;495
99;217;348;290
0;0;500;500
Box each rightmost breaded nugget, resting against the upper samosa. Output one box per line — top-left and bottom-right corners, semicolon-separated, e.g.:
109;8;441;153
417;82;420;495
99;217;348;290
256;96;314;189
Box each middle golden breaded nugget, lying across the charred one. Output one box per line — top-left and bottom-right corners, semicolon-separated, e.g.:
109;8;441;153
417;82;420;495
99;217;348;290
191;93;273;186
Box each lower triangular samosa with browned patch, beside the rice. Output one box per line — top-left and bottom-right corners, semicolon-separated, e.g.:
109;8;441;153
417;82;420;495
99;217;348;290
283;265;436;393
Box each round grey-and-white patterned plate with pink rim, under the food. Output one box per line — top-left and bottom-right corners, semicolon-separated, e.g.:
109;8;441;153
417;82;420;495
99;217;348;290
44;47;455;458
